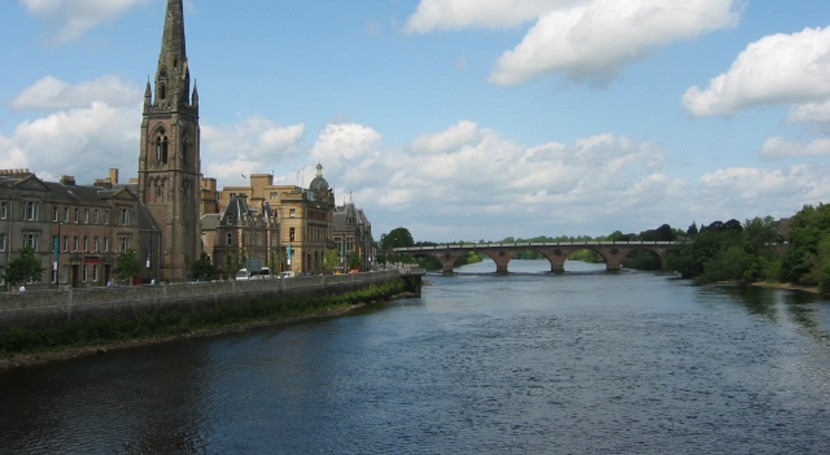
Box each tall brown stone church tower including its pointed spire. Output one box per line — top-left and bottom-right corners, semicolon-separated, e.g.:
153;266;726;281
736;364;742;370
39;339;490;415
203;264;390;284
138;0;202;281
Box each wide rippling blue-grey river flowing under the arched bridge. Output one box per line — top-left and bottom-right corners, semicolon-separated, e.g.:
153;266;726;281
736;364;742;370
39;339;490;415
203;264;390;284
0;261;830;454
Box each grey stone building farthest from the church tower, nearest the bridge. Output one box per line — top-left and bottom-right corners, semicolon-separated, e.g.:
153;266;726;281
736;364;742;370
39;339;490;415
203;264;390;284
332;202;374;270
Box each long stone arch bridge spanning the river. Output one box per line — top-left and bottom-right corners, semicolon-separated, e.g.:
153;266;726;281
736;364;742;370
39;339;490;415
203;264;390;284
392;241;675;274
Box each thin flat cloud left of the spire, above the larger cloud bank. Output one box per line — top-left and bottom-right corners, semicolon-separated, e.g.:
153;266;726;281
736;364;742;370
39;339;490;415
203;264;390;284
9;76;141;111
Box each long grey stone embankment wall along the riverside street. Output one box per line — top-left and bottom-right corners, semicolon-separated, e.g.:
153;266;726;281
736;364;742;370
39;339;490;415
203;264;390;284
0;271;402;331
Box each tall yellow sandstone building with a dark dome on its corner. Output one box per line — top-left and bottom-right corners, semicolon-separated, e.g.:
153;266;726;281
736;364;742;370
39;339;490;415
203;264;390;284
219;164;334;275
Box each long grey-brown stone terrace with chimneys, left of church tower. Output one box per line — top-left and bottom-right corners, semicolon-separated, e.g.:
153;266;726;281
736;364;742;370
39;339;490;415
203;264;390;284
0;169;160;287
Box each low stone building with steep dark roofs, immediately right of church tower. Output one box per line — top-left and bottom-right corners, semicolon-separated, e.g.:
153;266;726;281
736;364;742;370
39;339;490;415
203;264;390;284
202;194;285;277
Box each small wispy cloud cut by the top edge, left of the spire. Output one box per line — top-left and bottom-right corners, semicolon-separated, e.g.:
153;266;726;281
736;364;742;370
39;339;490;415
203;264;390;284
20;0;149;43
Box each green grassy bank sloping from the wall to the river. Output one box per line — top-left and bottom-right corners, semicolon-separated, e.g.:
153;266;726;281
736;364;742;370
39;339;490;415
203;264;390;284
0;280;405;368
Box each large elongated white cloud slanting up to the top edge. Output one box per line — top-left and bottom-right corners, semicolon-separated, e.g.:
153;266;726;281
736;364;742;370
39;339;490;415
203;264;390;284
490;0;738;85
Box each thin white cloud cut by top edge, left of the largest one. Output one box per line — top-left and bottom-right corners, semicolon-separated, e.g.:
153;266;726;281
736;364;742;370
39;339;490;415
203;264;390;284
406;0;576;33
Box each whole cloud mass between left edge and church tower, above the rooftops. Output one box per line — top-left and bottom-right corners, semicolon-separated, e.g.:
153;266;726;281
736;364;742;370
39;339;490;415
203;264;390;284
0;76;142;183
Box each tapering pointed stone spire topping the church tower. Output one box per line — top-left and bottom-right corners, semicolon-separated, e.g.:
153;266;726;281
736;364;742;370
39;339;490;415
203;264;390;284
155;0;190;109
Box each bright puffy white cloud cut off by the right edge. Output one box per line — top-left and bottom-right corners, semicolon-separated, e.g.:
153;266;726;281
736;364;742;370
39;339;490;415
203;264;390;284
683;27;830;117
